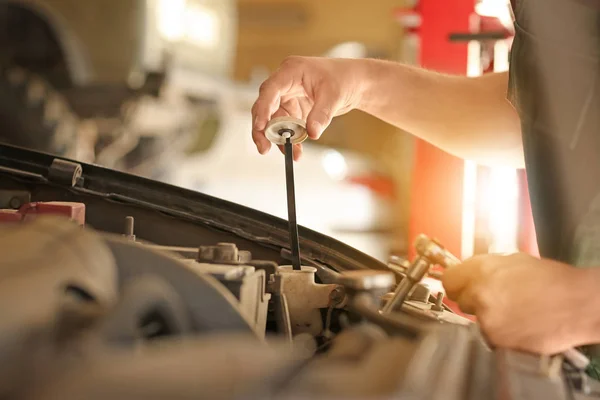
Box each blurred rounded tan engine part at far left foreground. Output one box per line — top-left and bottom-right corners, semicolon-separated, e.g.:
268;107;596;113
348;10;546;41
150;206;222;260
0;216;118;398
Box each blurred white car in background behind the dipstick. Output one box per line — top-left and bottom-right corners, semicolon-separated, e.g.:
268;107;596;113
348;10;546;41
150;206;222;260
169;89;392;260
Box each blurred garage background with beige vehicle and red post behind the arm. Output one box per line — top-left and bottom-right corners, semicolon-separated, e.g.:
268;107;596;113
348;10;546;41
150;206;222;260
0;0;535;260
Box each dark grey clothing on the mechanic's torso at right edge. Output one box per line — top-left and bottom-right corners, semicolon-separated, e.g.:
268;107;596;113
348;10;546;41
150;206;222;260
509;0;600;266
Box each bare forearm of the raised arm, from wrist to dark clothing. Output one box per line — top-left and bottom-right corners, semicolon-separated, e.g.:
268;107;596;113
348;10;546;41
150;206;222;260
359;60;524;167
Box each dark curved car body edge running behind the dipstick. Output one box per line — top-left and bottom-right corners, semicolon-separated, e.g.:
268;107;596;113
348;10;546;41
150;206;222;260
0;144;387;271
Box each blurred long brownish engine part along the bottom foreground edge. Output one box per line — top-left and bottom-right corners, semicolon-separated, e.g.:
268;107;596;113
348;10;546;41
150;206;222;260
25;334;307;400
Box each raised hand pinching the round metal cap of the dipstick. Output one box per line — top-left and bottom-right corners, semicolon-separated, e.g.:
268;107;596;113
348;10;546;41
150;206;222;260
252;57;363;160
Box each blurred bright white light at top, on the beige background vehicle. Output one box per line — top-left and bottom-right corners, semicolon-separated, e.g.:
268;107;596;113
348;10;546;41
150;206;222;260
156;0;219;47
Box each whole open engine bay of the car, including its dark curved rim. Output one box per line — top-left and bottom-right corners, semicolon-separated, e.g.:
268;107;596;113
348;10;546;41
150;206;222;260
0;145;600;400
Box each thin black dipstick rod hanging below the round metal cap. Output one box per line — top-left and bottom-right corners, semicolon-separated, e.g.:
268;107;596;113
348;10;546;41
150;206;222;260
279;129;301;271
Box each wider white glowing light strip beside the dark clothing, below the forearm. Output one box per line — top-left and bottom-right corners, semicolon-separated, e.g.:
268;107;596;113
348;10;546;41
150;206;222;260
485;167;519;253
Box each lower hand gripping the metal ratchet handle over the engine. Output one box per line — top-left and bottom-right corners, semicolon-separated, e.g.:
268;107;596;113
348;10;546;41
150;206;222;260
442;254;597;354
